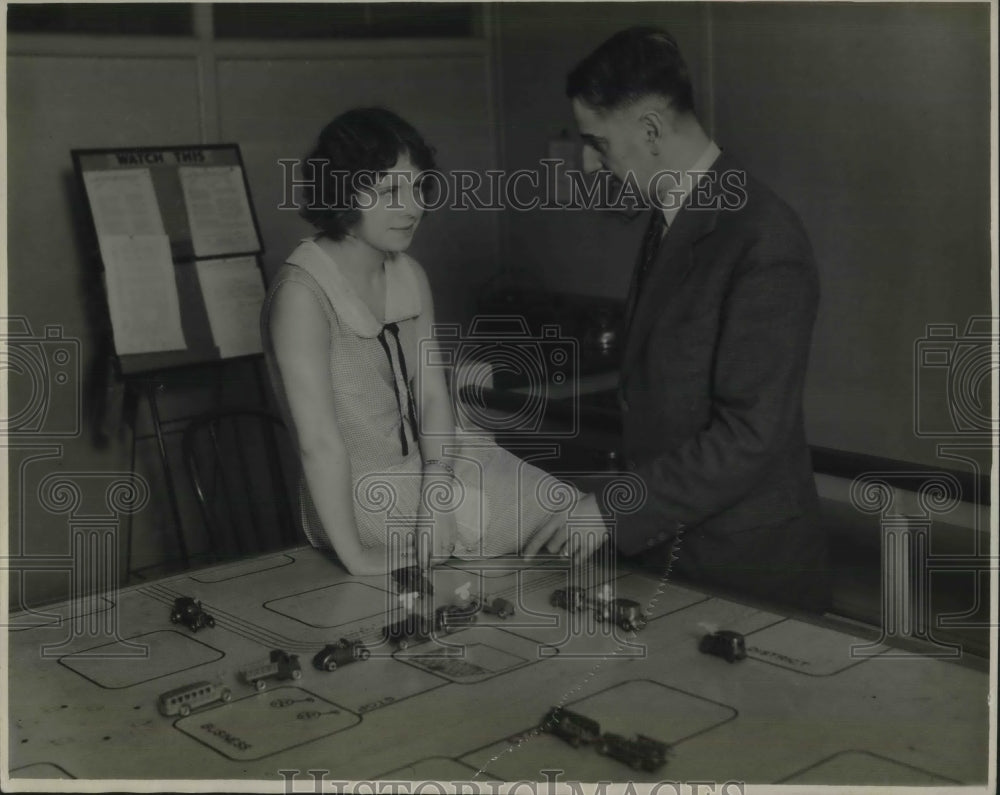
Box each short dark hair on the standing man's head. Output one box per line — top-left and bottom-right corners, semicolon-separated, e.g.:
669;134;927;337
566;27;694;113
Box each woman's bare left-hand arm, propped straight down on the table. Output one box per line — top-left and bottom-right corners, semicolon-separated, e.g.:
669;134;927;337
270;282;404;575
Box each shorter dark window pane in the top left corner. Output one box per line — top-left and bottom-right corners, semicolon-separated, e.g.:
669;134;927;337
7;3;194;36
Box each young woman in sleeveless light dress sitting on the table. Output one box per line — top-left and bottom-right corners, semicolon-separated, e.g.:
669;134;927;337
261;108;596;575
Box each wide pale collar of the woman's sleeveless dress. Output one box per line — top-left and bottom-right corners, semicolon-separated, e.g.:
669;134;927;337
287;238;421;337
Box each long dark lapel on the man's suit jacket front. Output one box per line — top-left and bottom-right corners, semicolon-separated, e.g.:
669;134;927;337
622;155;725;375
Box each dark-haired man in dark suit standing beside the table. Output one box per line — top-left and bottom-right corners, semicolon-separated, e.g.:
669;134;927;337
567;28;829;610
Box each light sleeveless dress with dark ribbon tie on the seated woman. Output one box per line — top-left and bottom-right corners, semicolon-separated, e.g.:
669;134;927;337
261;239;579;558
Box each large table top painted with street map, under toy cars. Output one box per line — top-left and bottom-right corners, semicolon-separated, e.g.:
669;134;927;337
4;548;989;787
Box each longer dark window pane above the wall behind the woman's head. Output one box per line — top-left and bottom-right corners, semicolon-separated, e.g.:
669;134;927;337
213;3;477;39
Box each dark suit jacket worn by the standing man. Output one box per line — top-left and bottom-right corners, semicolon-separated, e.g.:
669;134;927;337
602;153;826;606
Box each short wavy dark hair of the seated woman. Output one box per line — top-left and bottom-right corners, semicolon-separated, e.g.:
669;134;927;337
299;108;434;240
